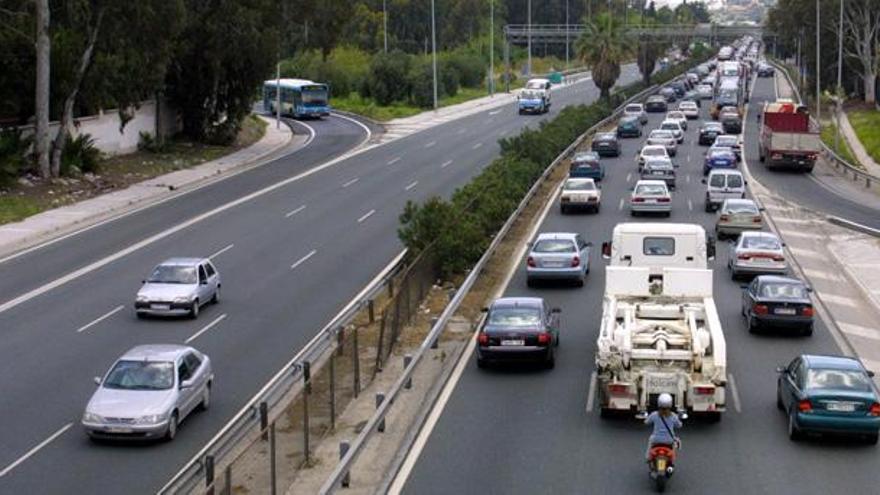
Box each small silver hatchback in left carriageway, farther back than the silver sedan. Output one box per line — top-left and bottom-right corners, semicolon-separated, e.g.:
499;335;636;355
134;258;221;318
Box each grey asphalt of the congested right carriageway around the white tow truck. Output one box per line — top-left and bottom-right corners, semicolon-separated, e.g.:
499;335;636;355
403;74;880;495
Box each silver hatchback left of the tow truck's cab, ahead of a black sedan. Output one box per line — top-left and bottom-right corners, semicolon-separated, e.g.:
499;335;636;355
526;232;593;287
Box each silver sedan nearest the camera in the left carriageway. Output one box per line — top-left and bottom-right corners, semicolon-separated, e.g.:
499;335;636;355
82;344;214;440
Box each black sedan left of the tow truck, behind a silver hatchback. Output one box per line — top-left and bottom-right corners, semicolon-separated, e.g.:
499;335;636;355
477;297;559;368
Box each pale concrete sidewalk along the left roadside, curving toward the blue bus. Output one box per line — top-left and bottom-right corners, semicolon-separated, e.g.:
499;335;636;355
0;116;300;263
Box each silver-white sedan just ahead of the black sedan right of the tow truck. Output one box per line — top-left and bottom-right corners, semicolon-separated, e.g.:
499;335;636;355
727;232;788;279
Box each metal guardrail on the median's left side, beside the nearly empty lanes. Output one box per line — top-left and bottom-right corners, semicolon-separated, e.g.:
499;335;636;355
158;250;407;495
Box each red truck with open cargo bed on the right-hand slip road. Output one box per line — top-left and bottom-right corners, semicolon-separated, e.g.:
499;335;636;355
758;100;822;172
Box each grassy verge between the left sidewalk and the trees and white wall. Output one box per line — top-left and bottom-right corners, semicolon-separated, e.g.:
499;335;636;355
0;116;266;225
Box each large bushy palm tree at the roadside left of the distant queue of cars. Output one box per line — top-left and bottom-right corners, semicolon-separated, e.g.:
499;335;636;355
574;13;632;99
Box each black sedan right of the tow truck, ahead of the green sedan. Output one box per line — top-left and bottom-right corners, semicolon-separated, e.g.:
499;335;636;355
741;275;813;335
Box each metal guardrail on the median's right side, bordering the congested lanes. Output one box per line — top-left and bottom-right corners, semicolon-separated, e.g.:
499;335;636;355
319;85;658;495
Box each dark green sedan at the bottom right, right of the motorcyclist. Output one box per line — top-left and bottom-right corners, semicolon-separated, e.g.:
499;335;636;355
776;354;880;445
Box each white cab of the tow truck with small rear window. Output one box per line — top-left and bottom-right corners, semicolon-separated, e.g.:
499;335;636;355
602;222;715;275
